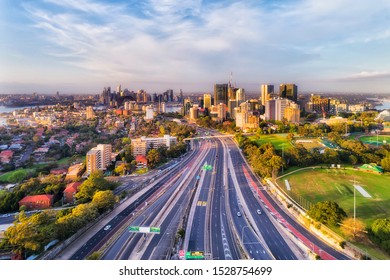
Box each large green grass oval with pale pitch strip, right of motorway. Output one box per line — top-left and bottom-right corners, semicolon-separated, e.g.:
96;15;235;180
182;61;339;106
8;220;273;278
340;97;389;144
278;169;390;225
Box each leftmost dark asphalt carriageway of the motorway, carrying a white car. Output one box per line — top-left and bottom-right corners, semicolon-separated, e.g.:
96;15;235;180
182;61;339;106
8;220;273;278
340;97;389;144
70;140;201;260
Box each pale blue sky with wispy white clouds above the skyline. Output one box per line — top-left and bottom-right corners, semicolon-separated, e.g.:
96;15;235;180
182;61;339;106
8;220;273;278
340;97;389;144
0;0;390;95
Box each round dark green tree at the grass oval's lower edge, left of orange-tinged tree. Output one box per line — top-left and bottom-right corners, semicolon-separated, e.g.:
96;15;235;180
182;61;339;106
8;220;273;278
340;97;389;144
307;201;347;226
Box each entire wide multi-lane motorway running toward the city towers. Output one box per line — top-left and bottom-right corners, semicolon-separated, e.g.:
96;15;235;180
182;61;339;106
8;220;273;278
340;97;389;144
52;129;347;260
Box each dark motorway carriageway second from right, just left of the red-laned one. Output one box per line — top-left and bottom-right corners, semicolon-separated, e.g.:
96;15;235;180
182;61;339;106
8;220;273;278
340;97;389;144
227;141;297;260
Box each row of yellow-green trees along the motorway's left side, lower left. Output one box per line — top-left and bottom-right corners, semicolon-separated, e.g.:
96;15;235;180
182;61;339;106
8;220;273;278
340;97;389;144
0;171;117;254
